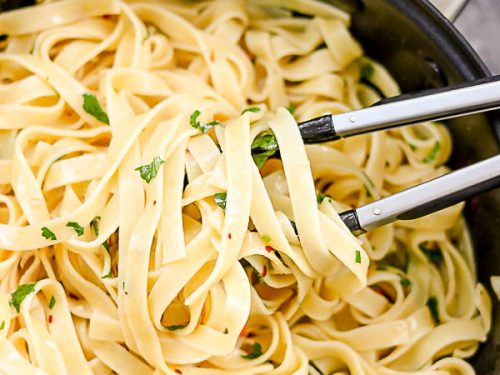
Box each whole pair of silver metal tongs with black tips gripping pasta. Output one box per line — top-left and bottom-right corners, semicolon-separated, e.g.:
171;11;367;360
299;75;500;235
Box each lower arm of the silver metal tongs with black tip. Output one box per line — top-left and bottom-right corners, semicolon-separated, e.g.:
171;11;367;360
340;155;500;234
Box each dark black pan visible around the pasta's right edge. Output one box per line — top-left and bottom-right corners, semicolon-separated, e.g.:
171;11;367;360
329;0;500;375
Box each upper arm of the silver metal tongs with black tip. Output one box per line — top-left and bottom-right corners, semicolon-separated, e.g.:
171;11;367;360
299;76;500;143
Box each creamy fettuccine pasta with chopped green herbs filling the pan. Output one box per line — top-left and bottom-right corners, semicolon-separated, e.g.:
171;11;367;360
0;0;491;375
